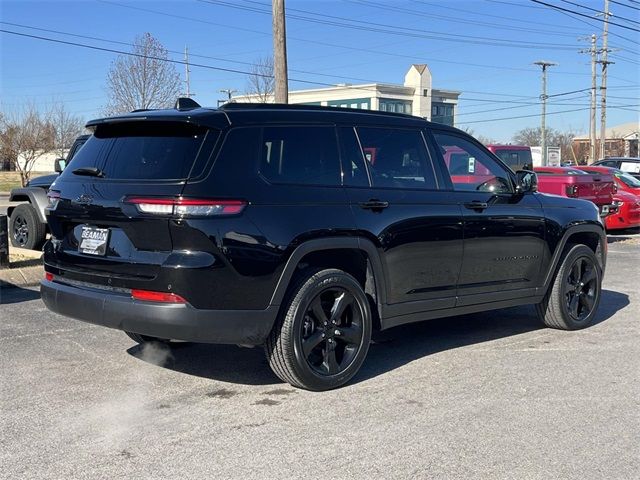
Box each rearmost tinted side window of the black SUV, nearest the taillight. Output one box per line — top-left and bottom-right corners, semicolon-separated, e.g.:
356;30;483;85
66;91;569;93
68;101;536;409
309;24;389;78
260;126;341;185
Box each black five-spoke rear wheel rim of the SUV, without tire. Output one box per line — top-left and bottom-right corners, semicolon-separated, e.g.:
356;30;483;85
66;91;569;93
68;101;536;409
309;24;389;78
301;287;363;375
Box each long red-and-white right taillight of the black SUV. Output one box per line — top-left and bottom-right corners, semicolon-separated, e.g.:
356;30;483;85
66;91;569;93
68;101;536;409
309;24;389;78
124;197;247;217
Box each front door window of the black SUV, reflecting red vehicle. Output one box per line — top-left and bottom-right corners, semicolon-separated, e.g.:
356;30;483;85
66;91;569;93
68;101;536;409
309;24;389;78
433;131;513;193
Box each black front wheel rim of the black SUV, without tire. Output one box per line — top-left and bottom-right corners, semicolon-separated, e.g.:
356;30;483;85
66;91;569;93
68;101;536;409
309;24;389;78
564;257;598;322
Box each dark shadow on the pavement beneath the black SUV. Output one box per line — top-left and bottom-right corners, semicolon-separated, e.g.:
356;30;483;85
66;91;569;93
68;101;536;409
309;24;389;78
127;290;629;385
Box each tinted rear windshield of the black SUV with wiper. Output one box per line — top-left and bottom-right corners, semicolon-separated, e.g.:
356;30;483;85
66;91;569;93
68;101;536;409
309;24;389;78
69;121;207;180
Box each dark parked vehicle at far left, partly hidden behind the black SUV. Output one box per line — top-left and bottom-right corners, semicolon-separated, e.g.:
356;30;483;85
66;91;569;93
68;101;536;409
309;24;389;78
7;135;89;250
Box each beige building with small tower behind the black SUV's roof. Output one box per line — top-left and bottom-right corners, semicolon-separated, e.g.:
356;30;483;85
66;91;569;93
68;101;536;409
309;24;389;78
232;64;461;125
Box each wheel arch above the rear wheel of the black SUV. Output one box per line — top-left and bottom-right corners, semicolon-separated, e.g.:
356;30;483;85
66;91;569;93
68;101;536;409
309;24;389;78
270;237;386;318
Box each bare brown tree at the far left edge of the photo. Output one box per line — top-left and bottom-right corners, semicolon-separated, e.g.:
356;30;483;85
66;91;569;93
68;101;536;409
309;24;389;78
0;103;55;186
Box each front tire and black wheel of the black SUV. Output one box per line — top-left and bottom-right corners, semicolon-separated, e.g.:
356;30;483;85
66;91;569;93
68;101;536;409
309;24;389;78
536;245;602;330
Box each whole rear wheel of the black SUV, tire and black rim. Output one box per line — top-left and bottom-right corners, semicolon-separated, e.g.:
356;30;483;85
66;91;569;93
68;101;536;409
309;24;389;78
265;269;372;391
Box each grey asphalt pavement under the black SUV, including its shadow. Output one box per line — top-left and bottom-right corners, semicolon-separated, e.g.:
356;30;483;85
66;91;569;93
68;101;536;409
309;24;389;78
0;237;640;480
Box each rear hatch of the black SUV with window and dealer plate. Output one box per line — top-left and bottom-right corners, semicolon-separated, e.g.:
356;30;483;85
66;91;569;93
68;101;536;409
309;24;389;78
45;119;219;286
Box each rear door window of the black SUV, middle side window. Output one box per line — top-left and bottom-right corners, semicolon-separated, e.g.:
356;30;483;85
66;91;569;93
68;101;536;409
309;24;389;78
358;127;436;189
